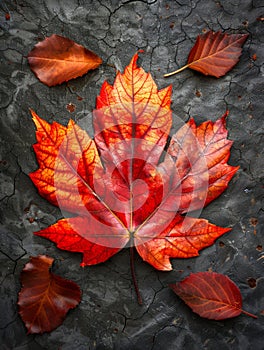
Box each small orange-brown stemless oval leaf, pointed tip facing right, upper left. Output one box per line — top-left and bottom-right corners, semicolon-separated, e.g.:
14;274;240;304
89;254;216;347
27;34;102;86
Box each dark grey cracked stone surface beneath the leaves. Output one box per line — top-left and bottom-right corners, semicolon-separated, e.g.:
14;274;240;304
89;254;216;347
0;0;264;350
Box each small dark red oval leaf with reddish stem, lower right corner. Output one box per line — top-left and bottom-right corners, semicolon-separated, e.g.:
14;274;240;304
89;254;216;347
169;272;257;320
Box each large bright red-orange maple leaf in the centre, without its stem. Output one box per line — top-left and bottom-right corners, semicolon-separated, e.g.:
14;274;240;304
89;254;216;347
30;54;238;271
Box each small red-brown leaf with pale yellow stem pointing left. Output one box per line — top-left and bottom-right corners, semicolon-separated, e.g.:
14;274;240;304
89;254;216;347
164;31;248;78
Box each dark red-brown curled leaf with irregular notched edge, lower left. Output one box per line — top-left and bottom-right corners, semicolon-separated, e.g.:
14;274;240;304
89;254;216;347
18;255;81;334
